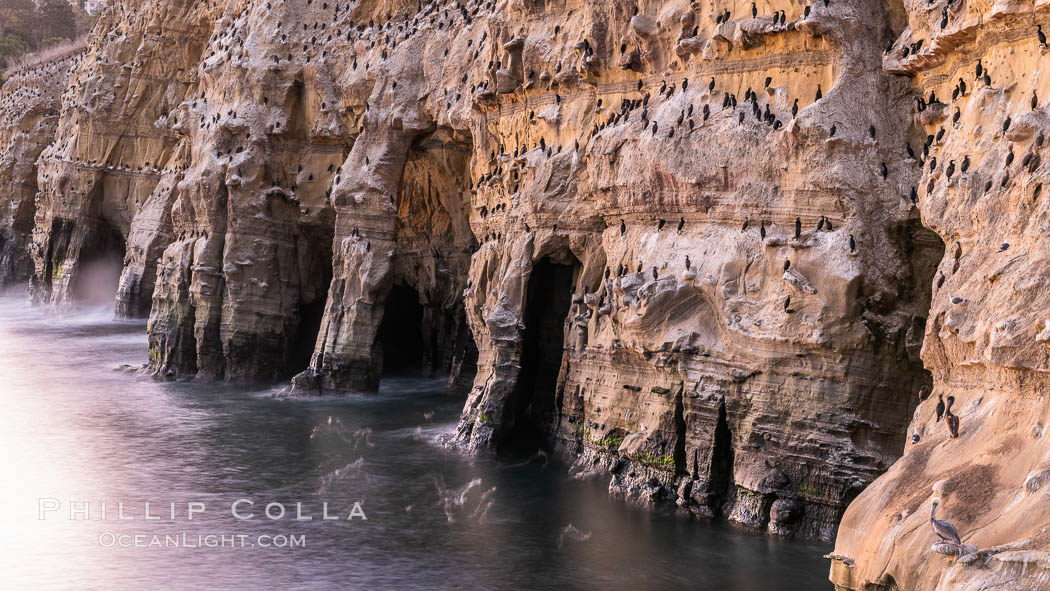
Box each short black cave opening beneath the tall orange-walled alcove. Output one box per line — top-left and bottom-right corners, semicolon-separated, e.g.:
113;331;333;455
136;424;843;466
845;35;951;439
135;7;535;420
376;283;427;376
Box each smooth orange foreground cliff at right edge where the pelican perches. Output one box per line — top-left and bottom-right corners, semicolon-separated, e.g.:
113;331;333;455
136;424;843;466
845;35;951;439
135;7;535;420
832;1;1050;590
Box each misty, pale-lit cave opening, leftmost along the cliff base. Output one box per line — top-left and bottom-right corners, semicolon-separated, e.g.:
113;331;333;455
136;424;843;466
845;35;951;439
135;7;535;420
72;223;125;305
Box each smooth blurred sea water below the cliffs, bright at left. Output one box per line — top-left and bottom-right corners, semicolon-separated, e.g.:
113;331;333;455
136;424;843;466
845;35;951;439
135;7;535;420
0;294;831;591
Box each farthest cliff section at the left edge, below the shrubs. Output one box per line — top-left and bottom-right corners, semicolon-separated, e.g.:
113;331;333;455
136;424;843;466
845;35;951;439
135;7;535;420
0;51;80;287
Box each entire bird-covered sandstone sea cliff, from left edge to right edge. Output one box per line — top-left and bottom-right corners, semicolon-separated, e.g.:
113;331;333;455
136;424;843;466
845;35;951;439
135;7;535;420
0;0;1050;590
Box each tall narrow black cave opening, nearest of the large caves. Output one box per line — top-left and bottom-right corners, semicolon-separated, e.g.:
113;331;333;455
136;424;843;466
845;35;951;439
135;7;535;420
503;258;575;450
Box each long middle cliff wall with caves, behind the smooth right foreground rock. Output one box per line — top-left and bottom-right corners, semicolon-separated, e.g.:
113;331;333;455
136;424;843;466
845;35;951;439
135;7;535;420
0;0;944;539
